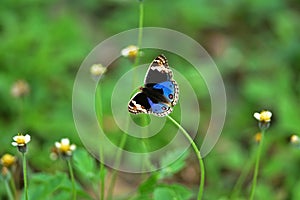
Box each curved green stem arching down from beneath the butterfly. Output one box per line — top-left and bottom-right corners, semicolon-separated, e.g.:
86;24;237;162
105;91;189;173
167;115;205;200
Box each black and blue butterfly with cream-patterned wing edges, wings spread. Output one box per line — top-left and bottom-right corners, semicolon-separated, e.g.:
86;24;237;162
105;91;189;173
128;55;179;117
